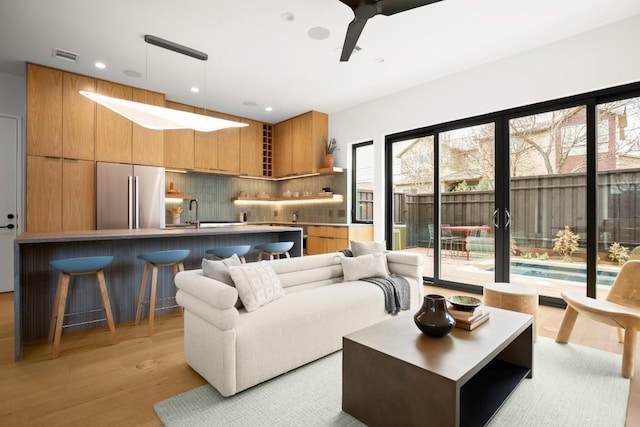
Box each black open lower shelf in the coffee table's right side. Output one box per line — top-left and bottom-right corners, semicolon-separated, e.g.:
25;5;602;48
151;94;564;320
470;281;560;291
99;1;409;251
460;360;531;426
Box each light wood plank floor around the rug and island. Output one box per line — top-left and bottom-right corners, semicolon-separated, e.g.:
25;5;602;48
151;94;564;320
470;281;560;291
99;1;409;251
0;287;640;427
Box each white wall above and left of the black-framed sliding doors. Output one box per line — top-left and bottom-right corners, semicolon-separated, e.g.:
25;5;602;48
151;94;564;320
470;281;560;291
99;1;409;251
329;15;640;240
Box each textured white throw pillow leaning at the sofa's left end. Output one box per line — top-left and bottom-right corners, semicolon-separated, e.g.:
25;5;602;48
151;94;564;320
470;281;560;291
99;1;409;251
229;261;284;311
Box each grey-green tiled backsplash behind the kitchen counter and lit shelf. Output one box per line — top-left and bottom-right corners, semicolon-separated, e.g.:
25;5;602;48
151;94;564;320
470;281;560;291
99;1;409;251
165;172;347;223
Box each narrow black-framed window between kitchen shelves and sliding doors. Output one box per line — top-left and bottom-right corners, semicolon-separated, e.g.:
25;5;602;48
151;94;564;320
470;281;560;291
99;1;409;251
351;141;373;223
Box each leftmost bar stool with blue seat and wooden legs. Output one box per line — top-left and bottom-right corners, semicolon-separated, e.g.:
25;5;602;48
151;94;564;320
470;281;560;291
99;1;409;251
49;256;116;357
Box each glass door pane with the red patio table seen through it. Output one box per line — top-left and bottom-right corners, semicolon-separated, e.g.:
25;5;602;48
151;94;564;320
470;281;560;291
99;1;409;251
434;123;495;285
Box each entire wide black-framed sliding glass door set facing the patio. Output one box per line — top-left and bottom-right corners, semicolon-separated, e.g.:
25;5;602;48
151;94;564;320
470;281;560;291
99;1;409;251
386;84;640;304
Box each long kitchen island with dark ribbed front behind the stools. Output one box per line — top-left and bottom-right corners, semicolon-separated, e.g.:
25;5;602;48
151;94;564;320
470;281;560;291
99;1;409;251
14;225;302;361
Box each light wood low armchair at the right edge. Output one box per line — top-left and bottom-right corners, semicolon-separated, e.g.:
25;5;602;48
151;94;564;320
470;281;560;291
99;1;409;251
556;261;640;378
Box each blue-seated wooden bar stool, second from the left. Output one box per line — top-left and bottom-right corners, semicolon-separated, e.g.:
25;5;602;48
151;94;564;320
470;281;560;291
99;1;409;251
136;249;191;336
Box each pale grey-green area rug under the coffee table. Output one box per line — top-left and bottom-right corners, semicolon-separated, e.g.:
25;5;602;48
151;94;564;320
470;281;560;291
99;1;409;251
154;337;629;427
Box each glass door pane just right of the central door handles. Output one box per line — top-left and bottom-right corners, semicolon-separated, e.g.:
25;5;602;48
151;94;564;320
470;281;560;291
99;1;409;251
509;106;588;298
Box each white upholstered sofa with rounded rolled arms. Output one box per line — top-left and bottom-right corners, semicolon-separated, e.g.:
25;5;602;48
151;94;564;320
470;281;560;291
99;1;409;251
175;252;423;396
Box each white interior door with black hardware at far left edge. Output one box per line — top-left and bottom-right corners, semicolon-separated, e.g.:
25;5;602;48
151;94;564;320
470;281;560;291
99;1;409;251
0;115;20;292
